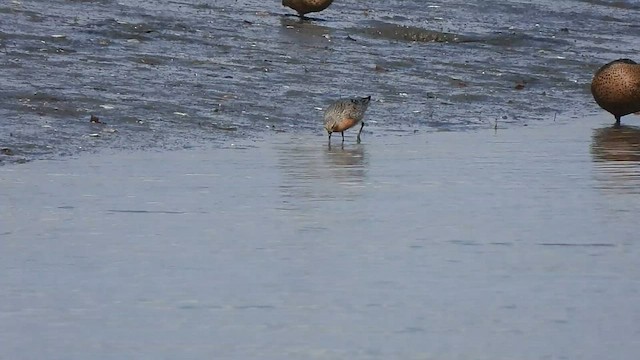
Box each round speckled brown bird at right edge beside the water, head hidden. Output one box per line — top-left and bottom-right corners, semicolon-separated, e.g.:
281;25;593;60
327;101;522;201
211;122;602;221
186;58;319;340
591;59;640;126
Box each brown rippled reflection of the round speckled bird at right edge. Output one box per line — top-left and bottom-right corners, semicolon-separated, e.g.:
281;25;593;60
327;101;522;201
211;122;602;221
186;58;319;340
591;126;640;194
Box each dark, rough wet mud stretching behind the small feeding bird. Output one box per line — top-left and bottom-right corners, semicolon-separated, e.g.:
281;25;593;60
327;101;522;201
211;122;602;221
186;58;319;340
0;0;640;163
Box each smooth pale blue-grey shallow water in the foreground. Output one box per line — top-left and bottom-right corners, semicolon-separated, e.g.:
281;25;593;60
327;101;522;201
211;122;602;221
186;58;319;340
0;116;640;360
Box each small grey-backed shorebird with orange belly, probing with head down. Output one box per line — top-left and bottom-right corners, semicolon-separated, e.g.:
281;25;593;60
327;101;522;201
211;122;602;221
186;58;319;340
324;96;371;145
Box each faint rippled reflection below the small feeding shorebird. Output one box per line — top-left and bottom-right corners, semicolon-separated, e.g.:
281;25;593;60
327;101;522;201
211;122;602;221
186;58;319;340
278;144;368;209
